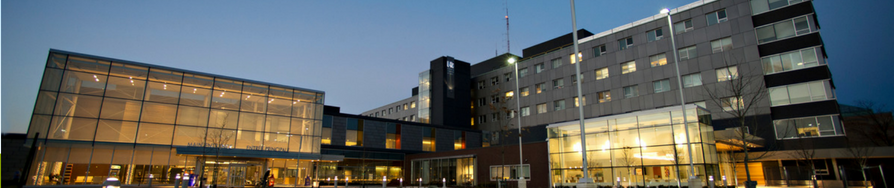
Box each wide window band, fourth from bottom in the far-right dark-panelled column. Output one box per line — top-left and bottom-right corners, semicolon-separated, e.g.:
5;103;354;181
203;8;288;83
755;16;811;43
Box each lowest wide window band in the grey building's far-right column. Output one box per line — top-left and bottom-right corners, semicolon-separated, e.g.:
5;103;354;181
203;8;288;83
773;116;844;139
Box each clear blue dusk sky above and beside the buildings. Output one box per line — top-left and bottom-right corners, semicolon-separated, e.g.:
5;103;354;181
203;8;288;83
0;0;894;133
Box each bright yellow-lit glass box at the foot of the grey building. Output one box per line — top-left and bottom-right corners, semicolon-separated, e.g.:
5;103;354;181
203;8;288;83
547;105;719;186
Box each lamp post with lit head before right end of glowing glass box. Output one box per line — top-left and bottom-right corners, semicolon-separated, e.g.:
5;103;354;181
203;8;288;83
661;9;701;187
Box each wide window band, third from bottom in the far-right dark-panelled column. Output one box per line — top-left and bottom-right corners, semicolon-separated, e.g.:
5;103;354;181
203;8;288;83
761;48;819;74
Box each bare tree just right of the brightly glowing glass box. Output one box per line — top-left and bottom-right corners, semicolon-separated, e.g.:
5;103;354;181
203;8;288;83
703;52;773;187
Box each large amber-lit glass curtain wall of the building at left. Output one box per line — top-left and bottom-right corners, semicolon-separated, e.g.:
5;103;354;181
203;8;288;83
28;51;324;185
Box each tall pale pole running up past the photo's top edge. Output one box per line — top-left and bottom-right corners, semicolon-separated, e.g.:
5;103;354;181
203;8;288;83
571;0;596;188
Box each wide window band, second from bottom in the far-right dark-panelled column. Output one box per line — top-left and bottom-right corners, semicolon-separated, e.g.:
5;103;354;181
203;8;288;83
769;81;834;106
